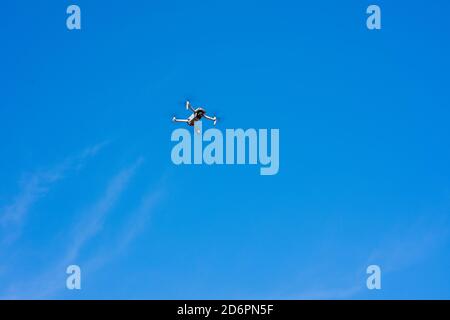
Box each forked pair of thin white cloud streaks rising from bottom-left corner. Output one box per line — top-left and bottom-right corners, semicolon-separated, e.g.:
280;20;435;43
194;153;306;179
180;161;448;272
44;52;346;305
0;158;161;299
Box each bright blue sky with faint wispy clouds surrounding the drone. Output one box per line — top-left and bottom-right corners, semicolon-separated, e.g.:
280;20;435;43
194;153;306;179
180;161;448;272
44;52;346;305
0;0;450;299
